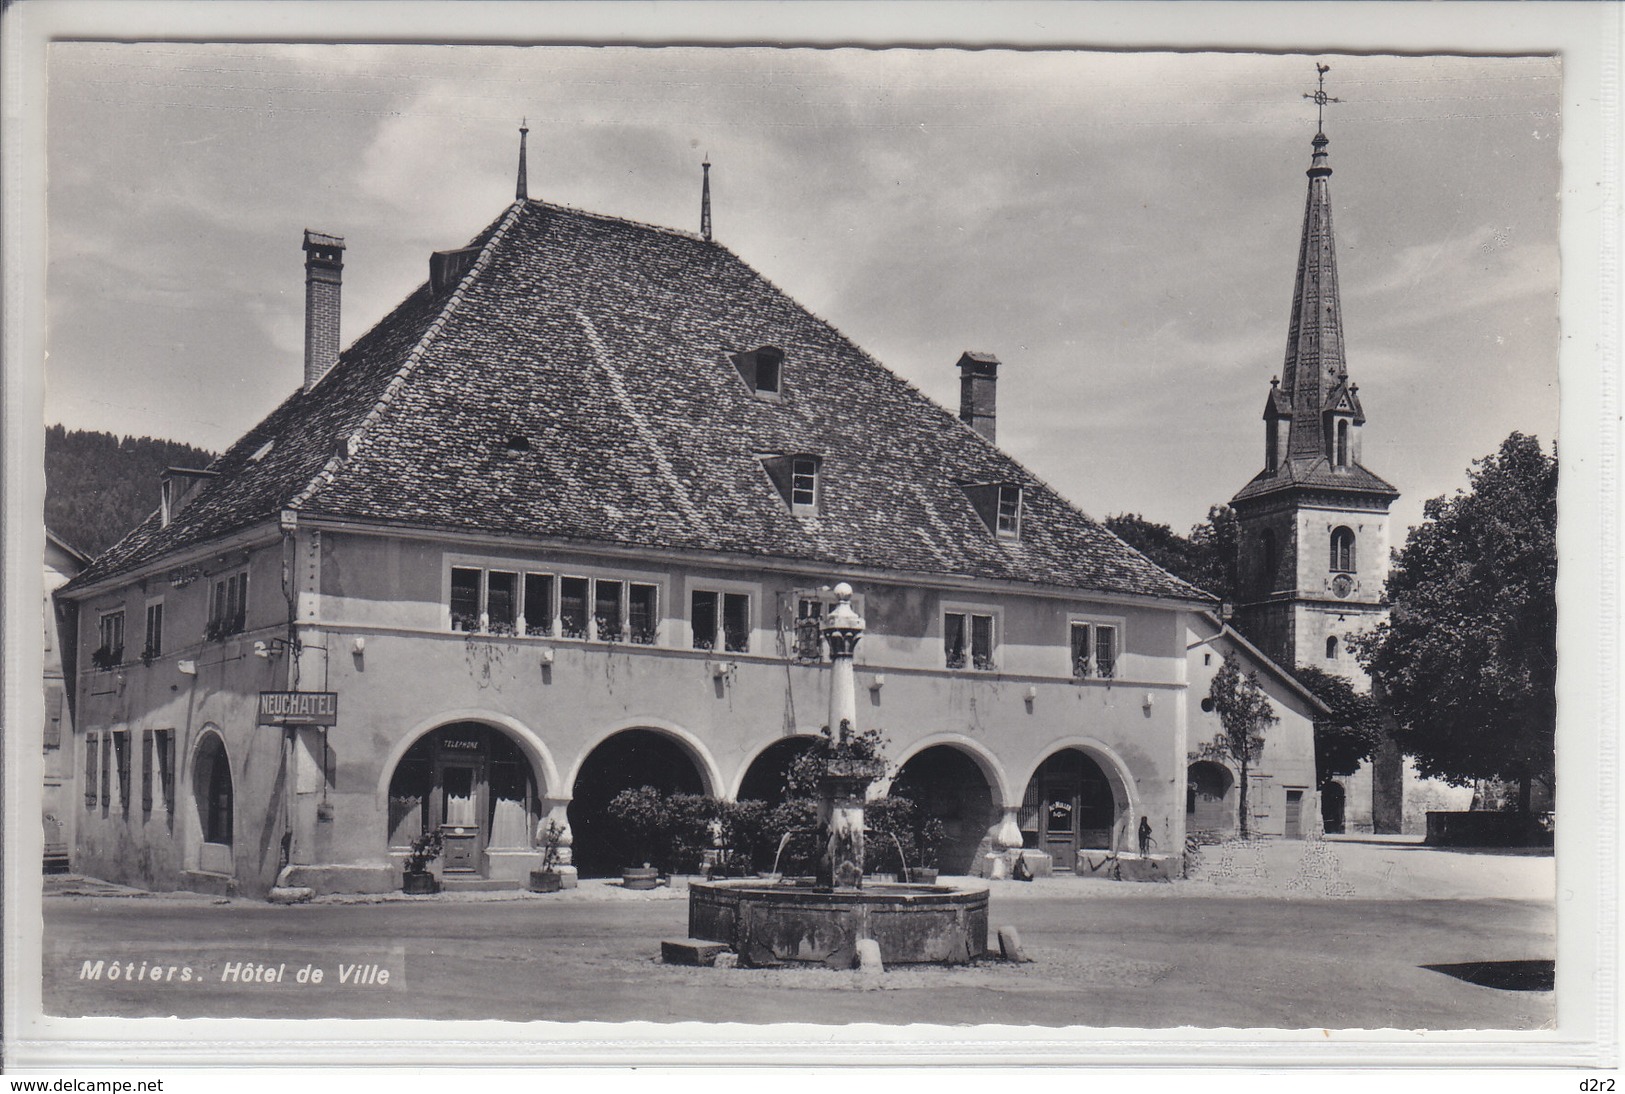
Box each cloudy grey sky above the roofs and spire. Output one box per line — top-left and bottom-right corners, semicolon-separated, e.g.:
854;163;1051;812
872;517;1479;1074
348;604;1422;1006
46;42;1563;538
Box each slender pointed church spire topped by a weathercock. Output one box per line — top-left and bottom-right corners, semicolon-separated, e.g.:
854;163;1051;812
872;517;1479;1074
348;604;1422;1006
1281;65;1349;460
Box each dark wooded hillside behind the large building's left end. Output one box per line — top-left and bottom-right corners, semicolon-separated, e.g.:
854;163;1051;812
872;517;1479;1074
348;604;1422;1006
46;426;215;558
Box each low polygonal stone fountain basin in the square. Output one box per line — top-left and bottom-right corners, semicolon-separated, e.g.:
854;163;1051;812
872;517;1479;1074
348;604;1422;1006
689;879;988;969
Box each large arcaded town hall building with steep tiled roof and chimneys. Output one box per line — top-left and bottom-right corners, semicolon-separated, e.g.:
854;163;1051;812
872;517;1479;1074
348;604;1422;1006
59;140;1332;892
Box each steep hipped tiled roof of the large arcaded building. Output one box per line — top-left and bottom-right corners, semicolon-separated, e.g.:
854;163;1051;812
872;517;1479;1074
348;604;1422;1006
75;202;1207;600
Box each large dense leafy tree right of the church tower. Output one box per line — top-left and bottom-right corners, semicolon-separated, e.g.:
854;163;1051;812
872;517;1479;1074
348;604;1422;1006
1354;432;1557;811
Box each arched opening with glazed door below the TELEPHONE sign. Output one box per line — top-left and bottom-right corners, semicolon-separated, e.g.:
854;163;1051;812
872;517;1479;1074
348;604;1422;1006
390;722;541;875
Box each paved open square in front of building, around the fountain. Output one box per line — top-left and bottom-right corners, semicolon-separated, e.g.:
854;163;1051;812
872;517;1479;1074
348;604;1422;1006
44;842;1557;1029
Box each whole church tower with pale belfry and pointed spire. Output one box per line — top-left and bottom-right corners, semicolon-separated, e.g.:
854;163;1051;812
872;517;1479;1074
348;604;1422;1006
1230;76;1399;689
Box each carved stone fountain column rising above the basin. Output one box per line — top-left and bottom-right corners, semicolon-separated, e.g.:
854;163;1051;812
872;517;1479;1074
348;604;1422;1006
817;582;879;889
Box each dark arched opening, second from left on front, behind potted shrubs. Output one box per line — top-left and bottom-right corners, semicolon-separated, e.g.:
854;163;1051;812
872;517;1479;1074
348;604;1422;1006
570;730;705;878
